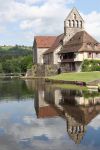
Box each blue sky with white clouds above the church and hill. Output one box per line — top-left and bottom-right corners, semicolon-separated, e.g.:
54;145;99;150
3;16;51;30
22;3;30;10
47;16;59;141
0;0;100;46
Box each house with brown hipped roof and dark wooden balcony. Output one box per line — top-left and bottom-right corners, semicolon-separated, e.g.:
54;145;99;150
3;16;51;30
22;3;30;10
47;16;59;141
59;31;100;71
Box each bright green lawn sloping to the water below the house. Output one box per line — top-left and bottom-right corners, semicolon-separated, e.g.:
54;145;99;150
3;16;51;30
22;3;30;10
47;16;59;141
48;72;100;82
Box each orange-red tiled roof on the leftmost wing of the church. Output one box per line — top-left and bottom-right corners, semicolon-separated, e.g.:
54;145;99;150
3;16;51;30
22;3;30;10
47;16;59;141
34;36;56;48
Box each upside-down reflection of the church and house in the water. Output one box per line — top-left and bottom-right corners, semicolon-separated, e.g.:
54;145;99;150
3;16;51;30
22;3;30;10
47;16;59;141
26;80;100;144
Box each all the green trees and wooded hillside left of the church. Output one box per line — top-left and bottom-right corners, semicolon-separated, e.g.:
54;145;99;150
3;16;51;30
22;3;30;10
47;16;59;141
0;45;32;73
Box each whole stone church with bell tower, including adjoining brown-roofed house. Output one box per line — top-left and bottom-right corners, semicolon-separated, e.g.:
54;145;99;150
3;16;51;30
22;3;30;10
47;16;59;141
33;8;100;72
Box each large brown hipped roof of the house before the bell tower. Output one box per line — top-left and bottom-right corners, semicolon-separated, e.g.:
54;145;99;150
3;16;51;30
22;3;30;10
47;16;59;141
59;31;100;53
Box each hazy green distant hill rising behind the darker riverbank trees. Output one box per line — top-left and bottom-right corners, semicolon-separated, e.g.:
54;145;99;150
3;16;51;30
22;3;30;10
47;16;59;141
0;45;32;59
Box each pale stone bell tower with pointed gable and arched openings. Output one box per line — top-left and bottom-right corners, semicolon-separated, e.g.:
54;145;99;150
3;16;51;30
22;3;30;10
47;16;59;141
64;7;84;42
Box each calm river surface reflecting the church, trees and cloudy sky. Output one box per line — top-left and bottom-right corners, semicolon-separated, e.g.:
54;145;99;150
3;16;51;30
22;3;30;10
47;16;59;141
0;80;100;150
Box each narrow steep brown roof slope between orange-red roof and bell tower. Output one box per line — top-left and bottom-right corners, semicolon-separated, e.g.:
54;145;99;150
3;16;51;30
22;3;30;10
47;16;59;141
44;34;64;55
